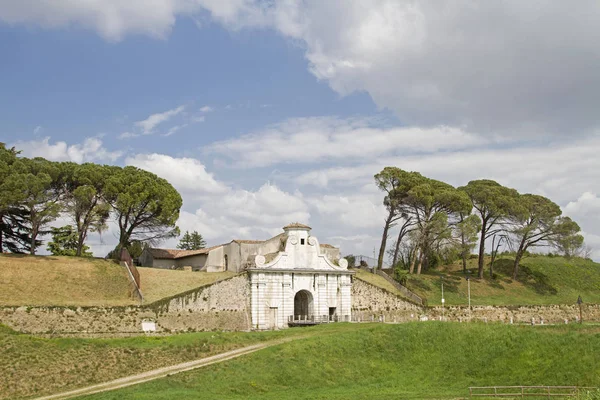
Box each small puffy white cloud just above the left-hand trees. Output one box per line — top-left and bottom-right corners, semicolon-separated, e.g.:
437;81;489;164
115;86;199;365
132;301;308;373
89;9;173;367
12;136;123;163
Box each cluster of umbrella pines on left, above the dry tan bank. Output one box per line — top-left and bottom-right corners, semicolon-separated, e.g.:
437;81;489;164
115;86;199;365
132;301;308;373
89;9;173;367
0;143;182;256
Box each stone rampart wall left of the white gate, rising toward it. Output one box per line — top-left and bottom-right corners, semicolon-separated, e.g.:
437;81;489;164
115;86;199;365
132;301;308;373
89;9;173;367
0;274;250;334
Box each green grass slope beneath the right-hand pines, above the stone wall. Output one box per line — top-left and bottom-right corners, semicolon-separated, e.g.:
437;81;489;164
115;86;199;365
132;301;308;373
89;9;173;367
407;255;600;305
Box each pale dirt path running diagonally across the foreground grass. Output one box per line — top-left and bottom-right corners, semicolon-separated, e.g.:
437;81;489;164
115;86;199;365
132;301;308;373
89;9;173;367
35;336;306;400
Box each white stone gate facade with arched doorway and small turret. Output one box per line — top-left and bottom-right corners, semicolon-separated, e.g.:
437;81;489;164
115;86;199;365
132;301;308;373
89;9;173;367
248;224;353;329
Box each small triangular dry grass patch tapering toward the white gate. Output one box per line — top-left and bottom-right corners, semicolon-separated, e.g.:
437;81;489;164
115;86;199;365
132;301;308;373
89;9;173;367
138;267;235;303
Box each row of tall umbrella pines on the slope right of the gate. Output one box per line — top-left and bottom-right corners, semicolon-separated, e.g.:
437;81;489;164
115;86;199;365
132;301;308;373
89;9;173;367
375;167;583;279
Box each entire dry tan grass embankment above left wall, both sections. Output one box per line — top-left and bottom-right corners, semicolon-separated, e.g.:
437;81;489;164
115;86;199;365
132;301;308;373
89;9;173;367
0;254;234;306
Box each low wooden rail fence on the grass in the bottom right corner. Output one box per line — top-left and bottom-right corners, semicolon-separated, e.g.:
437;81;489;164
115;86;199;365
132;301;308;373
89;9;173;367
469;386;598;399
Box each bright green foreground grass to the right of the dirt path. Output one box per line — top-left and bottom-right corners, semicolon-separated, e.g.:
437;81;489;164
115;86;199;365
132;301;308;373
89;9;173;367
82;322;600;400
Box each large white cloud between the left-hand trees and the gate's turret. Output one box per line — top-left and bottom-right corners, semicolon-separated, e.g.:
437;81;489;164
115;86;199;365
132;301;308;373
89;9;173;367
125;154;311;246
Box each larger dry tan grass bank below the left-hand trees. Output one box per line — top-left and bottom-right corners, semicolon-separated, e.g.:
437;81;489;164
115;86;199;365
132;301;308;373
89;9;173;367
0;254;134;306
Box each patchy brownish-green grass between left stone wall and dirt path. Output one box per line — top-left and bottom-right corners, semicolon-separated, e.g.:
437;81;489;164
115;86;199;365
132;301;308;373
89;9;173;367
0;325;347;399
